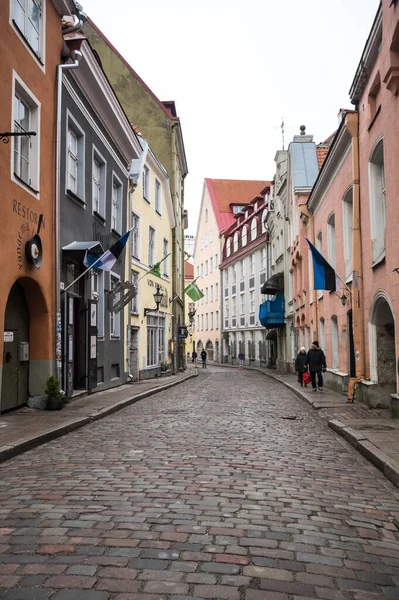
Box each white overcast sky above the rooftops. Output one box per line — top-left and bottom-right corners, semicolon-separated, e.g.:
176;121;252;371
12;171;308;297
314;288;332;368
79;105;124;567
79;0;379;233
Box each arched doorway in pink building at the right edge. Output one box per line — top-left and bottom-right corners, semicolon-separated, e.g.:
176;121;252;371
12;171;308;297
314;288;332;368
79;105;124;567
370;292;396;406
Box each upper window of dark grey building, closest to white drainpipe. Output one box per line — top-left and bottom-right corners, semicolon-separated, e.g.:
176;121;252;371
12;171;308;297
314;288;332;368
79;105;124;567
65;113;85;202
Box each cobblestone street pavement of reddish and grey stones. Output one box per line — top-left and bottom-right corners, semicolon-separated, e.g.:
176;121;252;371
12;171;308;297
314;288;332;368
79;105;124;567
0;367;399;600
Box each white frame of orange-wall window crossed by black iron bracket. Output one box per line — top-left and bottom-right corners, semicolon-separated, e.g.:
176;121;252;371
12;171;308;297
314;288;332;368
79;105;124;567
10;71;41;199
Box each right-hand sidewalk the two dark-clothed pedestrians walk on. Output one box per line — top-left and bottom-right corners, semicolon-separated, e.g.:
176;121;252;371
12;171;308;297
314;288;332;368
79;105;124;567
215;365;399;488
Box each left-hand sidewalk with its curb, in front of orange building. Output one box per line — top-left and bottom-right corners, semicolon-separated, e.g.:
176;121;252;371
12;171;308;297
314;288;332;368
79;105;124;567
0;365;198;462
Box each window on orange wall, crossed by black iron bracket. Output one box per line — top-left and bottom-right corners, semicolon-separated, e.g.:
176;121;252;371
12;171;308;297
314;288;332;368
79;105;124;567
11;73;40;195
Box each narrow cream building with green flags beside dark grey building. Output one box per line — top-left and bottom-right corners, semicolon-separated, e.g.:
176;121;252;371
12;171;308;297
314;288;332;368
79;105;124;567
125;138;175;380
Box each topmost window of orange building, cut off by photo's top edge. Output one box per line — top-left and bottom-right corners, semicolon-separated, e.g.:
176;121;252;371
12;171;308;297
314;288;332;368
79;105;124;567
11;0;45;62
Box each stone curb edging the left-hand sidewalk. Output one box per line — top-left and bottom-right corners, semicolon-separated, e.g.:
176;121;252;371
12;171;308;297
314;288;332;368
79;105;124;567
0;369;198;463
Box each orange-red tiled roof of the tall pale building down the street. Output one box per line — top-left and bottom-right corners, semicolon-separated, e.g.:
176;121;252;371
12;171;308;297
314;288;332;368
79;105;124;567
205;178;270;232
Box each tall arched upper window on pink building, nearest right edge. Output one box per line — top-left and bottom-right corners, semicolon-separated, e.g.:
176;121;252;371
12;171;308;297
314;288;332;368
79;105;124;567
369;140;386;263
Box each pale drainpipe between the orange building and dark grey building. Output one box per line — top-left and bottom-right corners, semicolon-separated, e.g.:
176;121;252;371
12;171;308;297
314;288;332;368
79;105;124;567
55;50;83;379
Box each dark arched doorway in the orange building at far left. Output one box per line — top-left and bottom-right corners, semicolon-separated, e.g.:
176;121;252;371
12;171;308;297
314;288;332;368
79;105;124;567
1;282;29;412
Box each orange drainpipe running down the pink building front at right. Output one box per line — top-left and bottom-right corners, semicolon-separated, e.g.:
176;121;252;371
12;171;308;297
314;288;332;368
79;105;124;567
346;112;365;402
